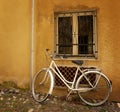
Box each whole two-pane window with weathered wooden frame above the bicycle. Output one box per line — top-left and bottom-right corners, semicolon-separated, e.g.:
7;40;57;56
55;11;97;58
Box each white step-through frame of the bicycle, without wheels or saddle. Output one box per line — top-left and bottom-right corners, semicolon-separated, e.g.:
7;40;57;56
46;49;109;92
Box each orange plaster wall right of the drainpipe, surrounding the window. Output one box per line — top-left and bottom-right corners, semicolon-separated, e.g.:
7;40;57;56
35;0;120;100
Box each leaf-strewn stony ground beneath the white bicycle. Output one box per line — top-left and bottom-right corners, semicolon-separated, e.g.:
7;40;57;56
0;82;120;112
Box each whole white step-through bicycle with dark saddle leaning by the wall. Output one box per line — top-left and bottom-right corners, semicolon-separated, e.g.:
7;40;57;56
32;49;112;106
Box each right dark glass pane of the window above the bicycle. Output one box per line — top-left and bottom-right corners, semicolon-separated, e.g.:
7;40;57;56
78;15;93;54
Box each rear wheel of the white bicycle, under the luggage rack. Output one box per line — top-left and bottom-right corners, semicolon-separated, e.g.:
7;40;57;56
76;71;111;106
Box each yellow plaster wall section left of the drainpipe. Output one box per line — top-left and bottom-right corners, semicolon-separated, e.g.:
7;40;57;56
0;0;31;86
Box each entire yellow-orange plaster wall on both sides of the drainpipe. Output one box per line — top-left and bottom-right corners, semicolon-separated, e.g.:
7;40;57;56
0;0;120;100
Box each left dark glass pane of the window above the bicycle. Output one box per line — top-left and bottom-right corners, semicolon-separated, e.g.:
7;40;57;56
58;17;72;54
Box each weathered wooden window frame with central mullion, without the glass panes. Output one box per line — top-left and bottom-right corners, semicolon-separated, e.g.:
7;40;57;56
54;10;98;59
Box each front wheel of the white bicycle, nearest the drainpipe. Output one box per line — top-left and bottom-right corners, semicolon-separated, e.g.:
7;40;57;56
32;68;53;102
